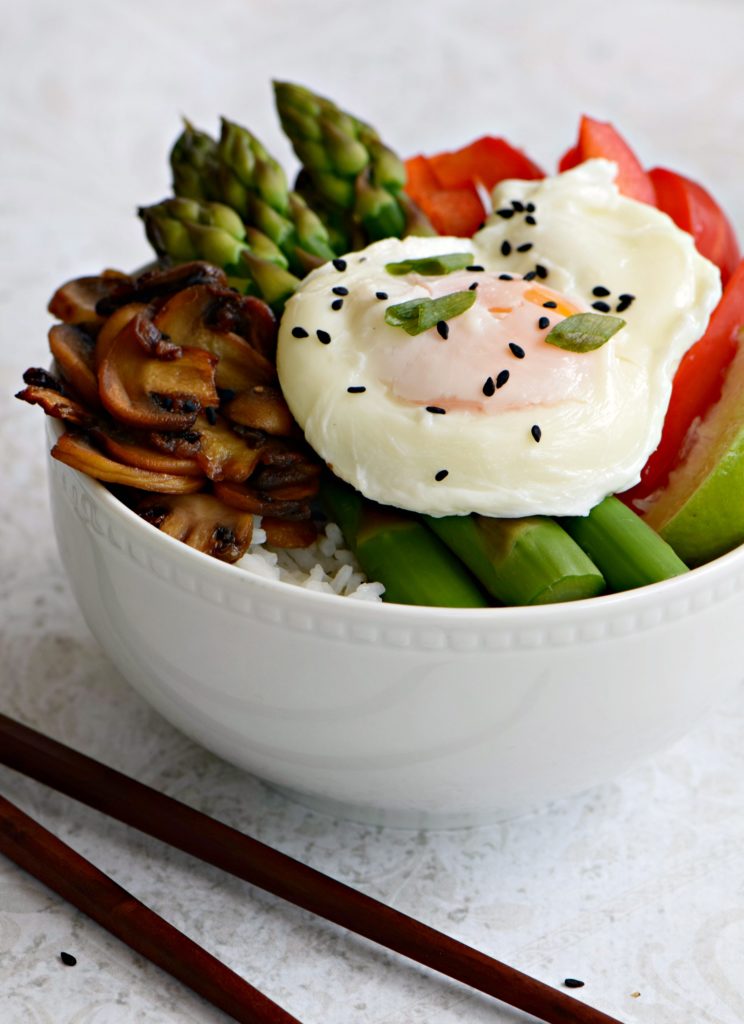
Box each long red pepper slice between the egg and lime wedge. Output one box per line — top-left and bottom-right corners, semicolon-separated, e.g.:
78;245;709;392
619;261;744;508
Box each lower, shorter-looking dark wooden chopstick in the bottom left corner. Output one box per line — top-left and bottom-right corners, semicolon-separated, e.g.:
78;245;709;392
0;796;300;1024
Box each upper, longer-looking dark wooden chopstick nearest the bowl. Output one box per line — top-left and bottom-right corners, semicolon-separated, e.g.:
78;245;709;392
0;715;621;1024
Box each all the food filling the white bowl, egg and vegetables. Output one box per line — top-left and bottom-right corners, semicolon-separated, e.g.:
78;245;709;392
21;84;744;607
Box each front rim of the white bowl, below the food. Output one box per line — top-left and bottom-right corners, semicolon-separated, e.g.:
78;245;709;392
46;417;744;628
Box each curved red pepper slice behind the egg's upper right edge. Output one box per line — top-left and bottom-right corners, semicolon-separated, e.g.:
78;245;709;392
649;167;741;285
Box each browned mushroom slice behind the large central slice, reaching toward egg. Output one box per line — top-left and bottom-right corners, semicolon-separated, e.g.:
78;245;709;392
154;285;276;392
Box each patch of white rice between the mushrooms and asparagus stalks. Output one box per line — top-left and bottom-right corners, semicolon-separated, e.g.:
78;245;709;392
235;516;385;601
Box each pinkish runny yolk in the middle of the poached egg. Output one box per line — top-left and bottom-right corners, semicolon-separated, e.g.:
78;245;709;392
370;271;600;415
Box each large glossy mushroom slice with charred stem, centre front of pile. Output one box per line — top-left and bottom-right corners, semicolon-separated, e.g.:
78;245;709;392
98;307;219;430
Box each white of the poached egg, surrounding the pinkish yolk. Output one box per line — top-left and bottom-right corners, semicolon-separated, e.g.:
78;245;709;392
277;160;720;517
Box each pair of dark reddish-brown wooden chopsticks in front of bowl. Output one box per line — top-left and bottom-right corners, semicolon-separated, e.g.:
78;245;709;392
0;715;621;1024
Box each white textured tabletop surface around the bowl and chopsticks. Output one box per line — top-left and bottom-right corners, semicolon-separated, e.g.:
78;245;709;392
0;0;744;1024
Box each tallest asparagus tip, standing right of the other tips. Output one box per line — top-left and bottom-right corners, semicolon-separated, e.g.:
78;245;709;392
274;82;435;249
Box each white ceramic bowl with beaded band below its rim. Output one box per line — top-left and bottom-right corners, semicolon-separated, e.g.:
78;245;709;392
49;424;744;827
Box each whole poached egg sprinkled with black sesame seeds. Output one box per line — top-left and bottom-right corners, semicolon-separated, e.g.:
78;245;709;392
277;160;720;517
